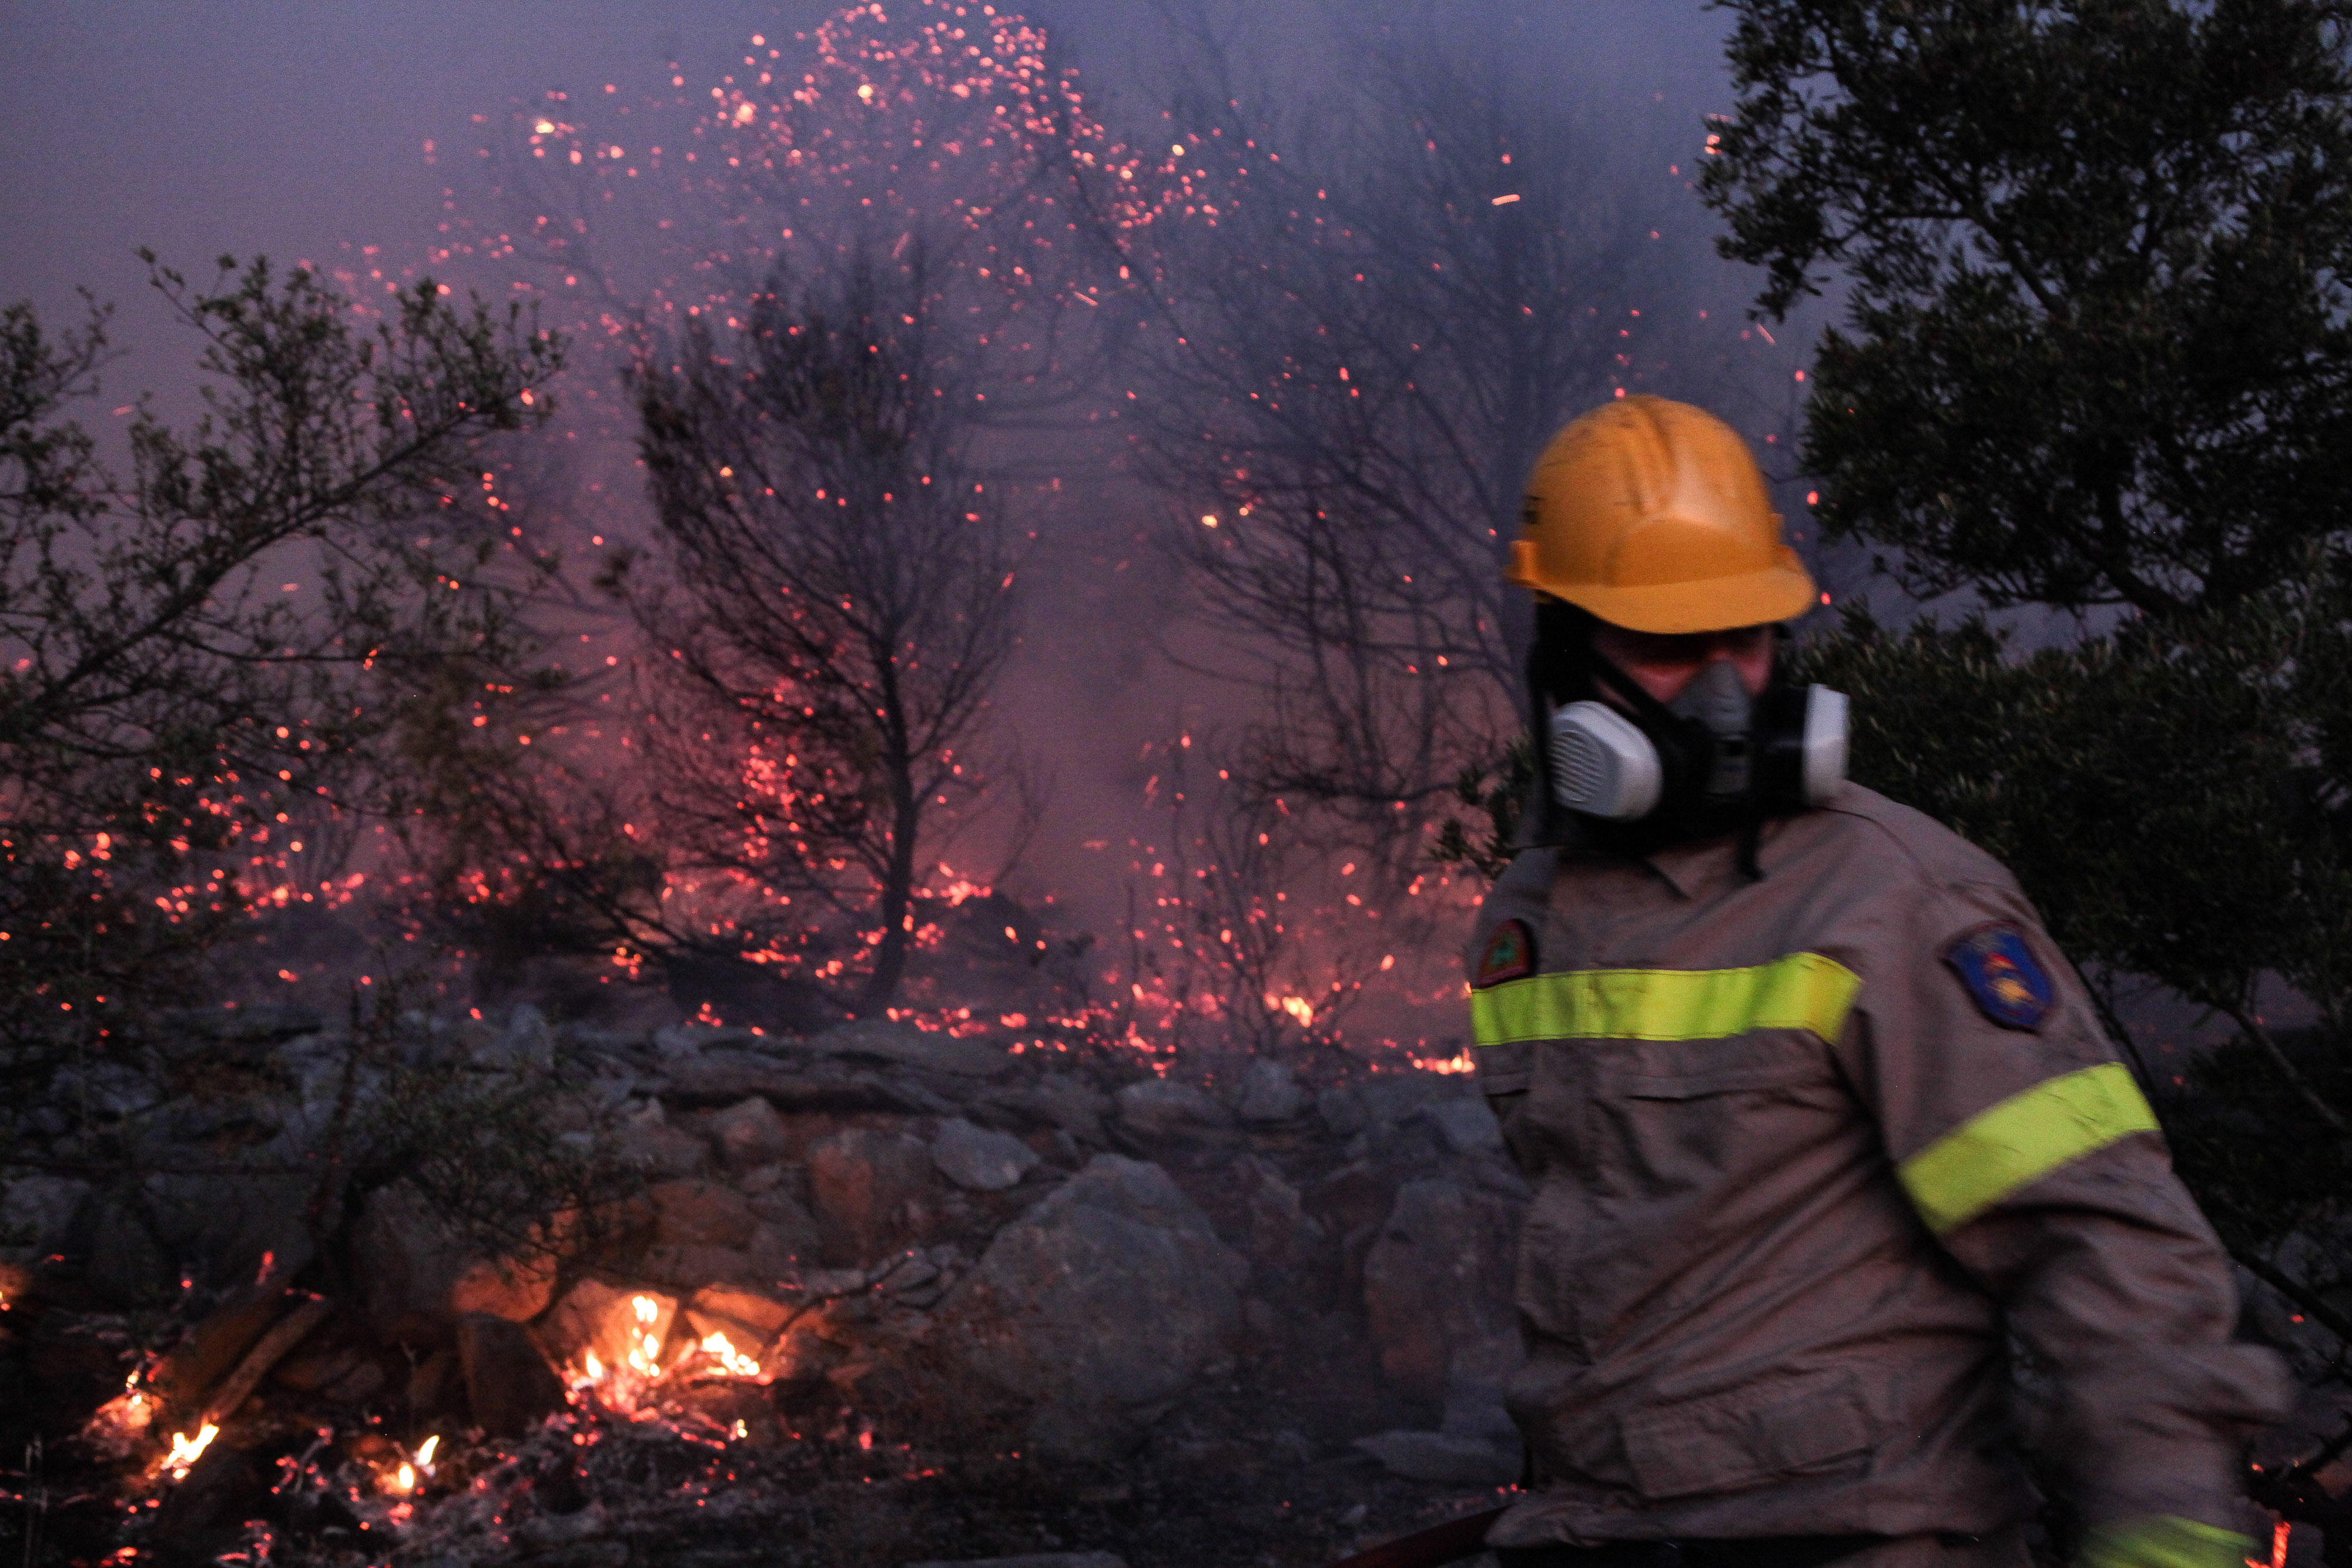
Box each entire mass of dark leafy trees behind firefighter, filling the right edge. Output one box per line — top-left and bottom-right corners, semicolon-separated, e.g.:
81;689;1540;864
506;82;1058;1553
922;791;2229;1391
1700;0;2352;1375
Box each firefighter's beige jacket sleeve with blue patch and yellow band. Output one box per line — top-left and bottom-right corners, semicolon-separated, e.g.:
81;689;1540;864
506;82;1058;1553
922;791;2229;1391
1832;879;2286;1563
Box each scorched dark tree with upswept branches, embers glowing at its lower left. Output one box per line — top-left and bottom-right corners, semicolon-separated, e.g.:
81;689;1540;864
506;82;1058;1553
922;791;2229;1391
623;256;1014;1013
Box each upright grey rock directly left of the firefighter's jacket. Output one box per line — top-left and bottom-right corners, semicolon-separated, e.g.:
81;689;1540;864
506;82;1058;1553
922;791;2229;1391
1364;1178;1519;1403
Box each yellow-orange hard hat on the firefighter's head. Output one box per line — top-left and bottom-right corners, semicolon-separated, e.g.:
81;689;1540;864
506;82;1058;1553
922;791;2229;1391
1510;397;1816;633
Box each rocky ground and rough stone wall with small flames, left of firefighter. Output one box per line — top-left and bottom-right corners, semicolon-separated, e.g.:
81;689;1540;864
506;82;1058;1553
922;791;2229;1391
0;982;1522;1568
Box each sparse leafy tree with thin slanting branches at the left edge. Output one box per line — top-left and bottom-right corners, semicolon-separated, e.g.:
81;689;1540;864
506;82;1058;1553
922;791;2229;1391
0;259;560;1105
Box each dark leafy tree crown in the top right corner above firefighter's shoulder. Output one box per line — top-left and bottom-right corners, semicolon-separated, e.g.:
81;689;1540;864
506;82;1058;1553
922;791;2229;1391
1700;0;2352;614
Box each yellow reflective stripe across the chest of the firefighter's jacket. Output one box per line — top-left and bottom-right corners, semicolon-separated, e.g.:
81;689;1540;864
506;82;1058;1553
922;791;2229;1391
1470;952;1863;1046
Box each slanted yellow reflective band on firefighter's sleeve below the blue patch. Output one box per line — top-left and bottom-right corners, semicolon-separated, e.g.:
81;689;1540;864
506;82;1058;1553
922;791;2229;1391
1896;1062;2157;1236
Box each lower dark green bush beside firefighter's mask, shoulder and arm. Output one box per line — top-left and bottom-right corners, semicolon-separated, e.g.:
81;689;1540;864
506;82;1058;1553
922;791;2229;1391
1795;601;2352;1363
